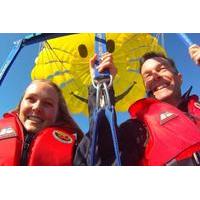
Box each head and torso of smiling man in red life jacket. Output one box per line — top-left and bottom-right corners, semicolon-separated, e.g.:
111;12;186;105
129;52;200;165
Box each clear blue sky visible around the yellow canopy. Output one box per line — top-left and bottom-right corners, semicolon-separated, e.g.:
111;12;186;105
0;33;200;132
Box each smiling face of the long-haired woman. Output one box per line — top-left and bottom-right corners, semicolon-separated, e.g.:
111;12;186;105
19;81;59;133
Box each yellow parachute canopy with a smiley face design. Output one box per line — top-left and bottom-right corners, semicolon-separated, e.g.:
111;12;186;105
31;33;166;115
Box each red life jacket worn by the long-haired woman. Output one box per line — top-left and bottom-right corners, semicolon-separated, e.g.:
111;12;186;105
0;113;76;166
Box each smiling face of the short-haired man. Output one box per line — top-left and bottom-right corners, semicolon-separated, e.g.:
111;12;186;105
141;57;182;104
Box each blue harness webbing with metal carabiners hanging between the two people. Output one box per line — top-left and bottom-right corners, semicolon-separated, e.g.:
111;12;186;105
90;33;121;165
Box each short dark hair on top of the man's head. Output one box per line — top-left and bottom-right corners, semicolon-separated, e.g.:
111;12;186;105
139;51;179;73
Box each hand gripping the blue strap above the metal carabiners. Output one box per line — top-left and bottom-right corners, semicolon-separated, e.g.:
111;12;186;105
90;52;117;79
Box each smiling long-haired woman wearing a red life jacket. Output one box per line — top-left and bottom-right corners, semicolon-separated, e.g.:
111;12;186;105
0;80;83;165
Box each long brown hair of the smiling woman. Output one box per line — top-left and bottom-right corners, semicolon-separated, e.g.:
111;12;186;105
14;79;83;142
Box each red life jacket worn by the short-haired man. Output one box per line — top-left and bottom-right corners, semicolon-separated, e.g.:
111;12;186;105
129;96;200;166
